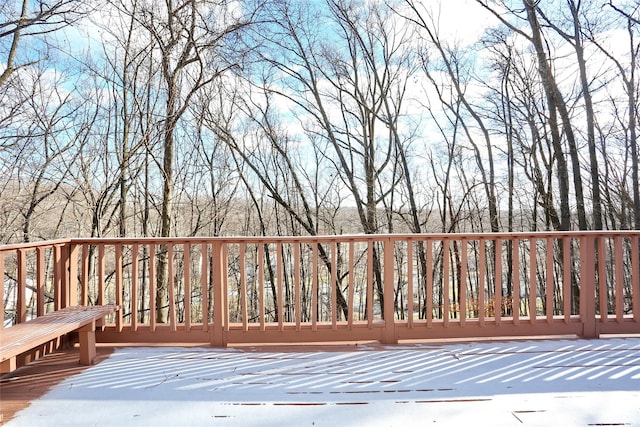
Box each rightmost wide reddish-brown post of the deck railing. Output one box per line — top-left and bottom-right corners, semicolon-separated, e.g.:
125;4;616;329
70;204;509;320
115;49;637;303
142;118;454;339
580;235;599;338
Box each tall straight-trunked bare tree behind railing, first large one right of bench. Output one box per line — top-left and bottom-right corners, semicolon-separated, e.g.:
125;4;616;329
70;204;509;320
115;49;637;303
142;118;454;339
130;0;251;322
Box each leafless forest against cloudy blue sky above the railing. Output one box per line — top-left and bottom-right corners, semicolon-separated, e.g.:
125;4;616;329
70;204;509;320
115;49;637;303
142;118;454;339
0;0;640;243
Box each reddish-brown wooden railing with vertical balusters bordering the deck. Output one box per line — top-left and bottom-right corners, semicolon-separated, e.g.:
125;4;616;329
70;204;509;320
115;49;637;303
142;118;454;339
0;231;640;346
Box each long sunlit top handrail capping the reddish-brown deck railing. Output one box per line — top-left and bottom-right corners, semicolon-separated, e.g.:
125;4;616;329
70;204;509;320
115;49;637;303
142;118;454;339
0;230;640;251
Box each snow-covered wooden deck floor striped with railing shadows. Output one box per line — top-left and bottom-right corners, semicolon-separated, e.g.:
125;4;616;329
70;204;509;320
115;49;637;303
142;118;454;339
0;337;640;427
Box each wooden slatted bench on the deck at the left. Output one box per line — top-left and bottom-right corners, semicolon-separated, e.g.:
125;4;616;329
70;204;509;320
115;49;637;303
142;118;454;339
0;305;118;374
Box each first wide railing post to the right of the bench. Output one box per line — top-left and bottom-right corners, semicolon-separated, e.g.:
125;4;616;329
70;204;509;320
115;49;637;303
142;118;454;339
211;240;227;347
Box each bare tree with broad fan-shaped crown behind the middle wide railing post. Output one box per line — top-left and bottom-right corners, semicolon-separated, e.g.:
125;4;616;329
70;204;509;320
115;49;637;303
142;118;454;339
252;0;432;315
